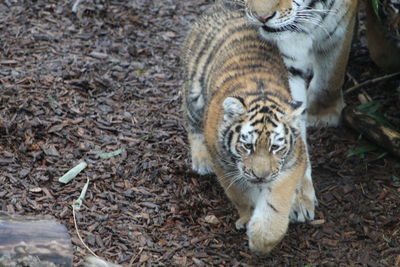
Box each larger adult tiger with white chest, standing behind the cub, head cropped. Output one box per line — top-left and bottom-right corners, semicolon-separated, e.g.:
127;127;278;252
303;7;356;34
244;0;358;126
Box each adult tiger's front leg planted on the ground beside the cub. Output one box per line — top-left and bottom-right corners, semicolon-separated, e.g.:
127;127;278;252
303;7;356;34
308;7;356;126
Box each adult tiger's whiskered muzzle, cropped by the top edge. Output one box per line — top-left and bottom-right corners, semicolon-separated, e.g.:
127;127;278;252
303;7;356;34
244;0;324;33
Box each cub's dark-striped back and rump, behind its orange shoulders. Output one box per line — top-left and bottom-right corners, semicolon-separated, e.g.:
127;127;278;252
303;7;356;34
183;1;291;141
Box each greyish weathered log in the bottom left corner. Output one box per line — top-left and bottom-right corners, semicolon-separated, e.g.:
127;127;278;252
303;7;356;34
0;213;72;266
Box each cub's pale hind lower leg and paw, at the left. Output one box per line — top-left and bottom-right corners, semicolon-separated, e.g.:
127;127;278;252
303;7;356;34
189;133;213;175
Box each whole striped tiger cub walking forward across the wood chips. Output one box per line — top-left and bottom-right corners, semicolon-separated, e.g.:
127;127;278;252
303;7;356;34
183;2;315;253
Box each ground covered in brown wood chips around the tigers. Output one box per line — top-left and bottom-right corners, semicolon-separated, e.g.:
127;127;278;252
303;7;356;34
0;0;400;266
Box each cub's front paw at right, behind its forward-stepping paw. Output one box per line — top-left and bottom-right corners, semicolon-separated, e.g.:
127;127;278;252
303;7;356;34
289;184;318;222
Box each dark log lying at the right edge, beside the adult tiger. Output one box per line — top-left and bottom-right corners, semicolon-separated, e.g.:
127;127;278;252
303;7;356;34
343;107;400;157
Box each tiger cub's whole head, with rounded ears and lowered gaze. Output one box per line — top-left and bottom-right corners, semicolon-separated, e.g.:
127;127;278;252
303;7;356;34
220;97;304;184
